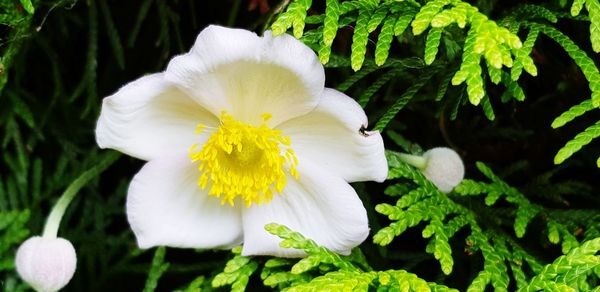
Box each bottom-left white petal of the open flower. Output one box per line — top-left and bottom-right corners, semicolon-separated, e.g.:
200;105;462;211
127;154;242;248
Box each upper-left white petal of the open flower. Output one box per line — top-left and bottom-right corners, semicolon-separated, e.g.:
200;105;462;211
96;74;218;160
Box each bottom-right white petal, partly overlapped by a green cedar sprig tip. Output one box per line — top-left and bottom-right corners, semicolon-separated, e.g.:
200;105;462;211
242;162;369;257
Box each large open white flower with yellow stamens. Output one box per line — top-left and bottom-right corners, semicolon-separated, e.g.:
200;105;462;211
96;26;387;256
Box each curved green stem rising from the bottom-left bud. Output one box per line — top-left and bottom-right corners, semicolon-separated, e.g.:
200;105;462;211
42;152;121;238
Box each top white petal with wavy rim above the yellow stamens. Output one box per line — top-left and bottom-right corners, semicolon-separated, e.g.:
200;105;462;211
165;26;325;125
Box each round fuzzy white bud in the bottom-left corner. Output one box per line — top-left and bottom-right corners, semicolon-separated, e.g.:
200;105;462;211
15;236;77;292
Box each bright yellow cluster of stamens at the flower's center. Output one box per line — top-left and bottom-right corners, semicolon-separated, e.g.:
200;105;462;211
190;112;298;207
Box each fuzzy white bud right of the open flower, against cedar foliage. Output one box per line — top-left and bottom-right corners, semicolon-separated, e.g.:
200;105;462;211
423;147;465;193
